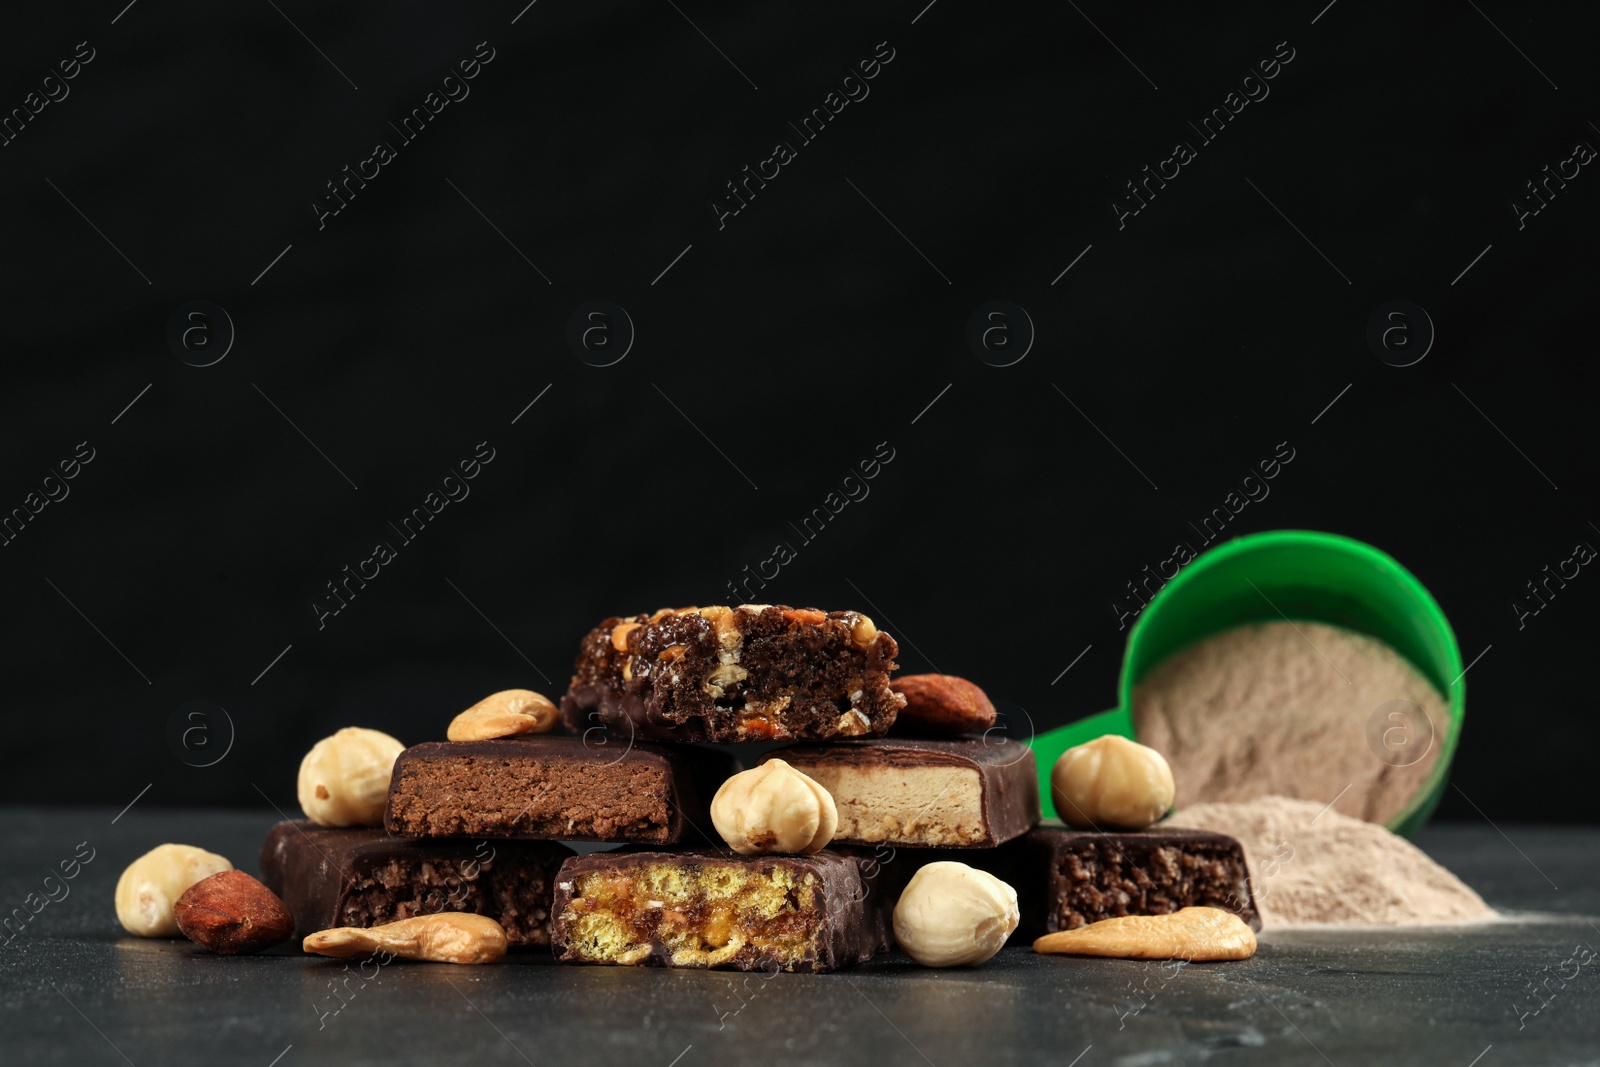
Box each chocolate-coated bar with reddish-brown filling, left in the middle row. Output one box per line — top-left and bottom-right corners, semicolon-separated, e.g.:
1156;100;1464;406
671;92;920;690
384;734;739;845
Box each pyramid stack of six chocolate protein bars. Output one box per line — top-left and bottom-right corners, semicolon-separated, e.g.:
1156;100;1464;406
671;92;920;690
261;605;1256;971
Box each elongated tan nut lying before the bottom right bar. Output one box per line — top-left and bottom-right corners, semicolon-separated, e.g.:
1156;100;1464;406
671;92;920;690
1034;907;1256;960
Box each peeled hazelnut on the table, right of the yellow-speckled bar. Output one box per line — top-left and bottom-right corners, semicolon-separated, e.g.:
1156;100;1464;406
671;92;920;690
894;861;1021;966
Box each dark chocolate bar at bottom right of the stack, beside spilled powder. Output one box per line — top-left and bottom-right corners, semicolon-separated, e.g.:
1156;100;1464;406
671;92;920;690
985;825;1261;937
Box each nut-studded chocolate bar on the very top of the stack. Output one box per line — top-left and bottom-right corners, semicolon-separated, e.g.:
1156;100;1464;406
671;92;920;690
562;605;906;741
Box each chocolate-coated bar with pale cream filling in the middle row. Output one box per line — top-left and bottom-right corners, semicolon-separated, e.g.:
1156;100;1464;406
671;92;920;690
763;737;1038;848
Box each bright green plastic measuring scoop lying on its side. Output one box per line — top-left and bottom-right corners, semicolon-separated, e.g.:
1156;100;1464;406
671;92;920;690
1030;530;1467;833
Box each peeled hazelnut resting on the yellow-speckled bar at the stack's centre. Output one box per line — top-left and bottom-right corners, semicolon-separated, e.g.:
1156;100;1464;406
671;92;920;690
710;760;838;856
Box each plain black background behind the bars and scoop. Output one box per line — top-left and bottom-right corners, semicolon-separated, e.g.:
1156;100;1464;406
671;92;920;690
0;0;1600;821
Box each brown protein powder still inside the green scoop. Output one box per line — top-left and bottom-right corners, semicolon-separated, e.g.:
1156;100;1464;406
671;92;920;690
1133;622;1450;822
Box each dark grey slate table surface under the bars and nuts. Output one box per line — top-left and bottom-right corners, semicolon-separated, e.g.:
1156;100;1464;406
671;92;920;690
0;805;1600;1067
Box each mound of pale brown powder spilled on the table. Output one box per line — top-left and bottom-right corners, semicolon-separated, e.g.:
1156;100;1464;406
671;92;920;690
1162;797;1496;926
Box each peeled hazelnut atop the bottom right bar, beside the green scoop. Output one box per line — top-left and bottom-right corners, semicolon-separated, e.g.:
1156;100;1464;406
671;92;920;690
1050;734;1174;830
